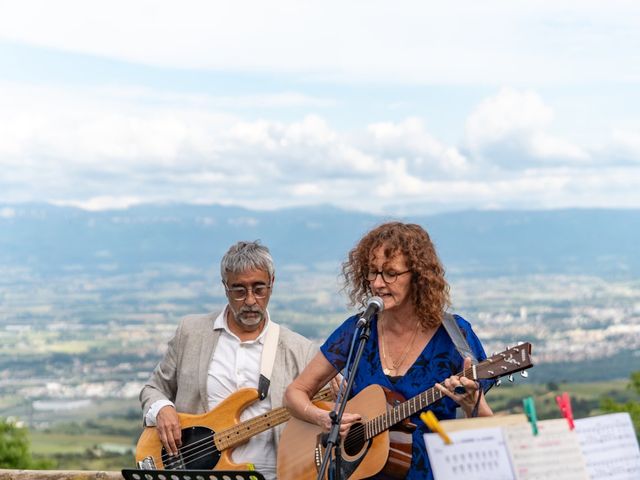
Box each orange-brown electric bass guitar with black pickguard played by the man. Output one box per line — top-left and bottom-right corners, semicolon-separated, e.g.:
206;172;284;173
135;388;333;470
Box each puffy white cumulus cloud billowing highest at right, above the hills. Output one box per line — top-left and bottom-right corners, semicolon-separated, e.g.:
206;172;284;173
466;88;589;169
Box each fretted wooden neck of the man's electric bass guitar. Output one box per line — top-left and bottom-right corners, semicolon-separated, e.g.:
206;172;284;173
213;388;332;451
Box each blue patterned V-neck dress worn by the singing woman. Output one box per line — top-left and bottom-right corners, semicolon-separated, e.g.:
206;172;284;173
320;315;492;480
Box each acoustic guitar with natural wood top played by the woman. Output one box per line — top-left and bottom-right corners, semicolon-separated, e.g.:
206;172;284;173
278;343;533;480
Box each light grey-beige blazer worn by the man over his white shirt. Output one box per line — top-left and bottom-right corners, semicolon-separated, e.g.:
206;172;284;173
140;313;319;436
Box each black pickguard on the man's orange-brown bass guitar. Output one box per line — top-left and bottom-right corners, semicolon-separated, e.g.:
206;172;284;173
162;427;220;470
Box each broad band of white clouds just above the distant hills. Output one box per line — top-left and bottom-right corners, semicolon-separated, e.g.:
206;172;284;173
0;83;640;215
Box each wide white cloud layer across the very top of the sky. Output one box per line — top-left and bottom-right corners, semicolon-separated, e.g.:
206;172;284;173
0;0;640;85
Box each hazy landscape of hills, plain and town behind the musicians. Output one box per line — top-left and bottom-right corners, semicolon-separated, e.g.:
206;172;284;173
0;204;640;470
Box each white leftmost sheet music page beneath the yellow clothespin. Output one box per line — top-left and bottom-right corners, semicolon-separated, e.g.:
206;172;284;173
424;428;516;480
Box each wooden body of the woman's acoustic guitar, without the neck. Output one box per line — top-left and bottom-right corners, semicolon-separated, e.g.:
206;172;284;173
278;385;412;480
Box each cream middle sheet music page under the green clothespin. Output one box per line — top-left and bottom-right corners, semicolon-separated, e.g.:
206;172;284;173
503;418;589;480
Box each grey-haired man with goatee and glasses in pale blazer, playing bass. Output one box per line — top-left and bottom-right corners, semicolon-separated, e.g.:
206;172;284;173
140;241;317;479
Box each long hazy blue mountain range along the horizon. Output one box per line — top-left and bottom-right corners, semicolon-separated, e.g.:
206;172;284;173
0;204;640;277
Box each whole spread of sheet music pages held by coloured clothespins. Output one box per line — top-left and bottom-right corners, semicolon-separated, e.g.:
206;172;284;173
424;413;640;480
